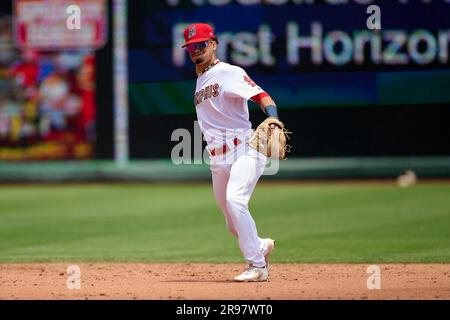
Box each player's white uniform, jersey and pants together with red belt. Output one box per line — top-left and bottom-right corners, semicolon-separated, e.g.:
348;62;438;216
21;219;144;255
195;60;266;267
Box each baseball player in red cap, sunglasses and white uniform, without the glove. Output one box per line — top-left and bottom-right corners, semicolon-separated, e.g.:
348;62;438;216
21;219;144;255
182;23;278;282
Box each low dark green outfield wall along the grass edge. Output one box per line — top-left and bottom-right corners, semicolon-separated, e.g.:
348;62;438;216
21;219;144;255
0;157;450;183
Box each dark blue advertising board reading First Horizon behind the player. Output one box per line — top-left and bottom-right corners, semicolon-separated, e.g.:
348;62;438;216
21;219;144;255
129;0;450;115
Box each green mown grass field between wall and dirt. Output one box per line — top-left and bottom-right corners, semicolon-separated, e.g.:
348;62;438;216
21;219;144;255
0;183;450;263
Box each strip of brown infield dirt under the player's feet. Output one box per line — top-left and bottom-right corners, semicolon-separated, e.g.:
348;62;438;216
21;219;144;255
0;263;450;300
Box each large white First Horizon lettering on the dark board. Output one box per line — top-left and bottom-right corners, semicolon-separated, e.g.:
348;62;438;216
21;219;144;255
172;21;450;66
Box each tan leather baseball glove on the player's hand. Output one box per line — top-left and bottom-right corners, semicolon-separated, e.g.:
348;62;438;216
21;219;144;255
249;117;291;160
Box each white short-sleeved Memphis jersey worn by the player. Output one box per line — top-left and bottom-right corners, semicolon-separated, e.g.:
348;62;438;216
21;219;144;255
194;62;264;148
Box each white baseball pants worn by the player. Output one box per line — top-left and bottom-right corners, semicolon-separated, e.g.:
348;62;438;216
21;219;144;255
211;144;267;267
